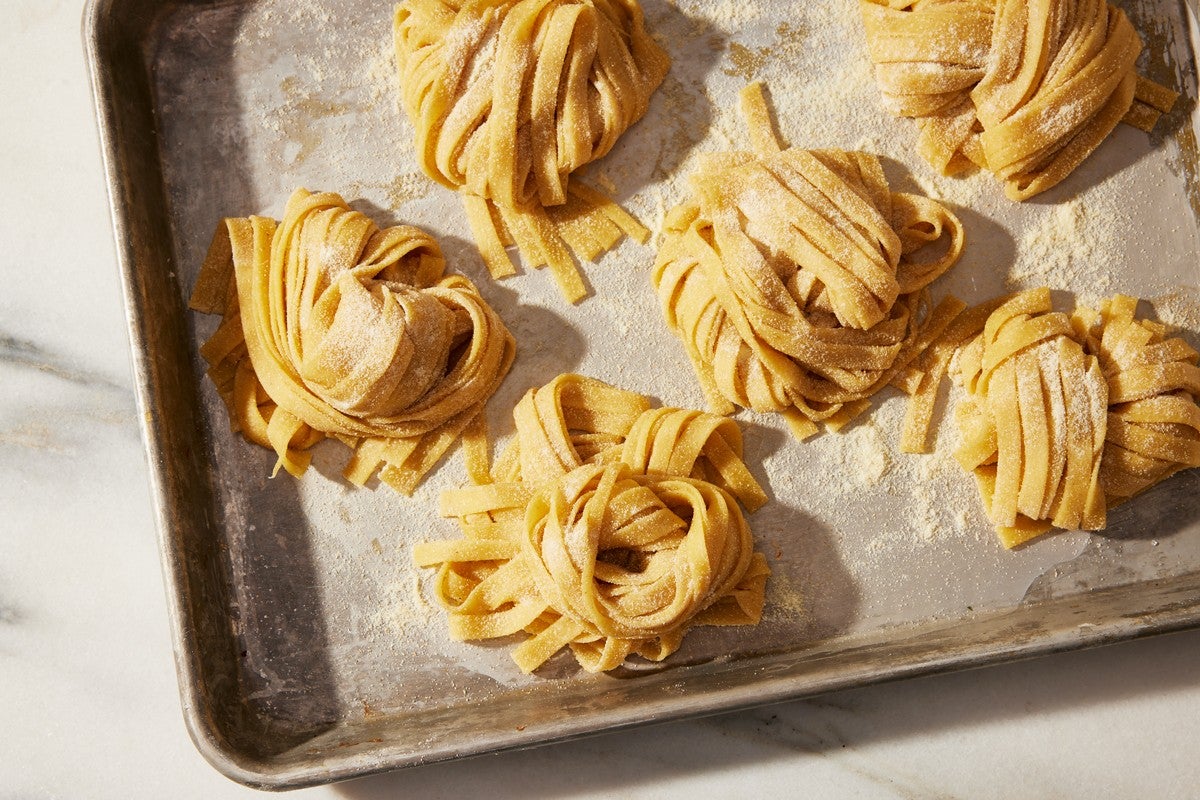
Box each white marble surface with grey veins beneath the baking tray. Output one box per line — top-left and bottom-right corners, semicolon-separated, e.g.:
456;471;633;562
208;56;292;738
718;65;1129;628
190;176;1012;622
7;0;1200;799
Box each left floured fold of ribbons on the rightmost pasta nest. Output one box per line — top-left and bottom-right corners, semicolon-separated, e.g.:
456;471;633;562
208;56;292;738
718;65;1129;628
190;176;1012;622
955;289;1108;547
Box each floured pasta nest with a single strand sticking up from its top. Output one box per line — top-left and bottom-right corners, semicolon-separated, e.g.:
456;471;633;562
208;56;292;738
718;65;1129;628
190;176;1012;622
654;84;964;438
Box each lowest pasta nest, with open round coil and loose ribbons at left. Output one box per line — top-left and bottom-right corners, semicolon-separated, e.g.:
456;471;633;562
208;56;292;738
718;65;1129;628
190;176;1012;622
413;374;768;672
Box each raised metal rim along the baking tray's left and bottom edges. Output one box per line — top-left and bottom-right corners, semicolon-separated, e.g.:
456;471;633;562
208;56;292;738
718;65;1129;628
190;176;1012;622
82;0;1200;790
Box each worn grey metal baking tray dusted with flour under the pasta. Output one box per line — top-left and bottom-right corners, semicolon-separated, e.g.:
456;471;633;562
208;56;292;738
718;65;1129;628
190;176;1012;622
85;0;1200;789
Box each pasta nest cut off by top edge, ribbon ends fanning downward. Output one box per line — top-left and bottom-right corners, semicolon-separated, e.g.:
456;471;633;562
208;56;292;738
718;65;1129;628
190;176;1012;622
395;0;670;302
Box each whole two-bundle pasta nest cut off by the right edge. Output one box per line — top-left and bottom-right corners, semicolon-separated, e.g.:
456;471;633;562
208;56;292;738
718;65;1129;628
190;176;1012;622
955;289;1200;547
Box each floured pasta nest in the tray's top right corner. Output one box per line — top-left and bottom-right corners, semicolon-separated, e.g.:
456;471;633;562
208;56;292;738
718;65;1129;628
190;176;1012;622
862;0;1177;200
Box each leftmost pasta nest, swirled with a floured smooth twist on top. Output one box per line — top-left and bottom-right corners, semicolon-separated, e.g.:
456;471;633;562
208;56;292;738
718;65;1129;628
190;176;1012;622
191;190;515;494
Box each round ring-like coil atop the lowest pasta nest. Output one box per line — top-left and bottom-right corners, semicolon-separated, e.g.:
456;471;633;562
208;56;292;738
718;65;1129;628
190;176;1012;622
523;463;754;638
